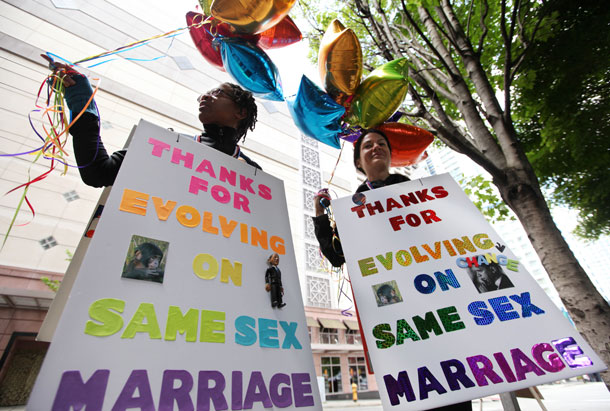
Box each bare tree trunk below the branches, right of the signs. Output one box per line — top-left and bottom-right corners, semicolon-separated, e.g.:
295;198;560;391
496;170;610;390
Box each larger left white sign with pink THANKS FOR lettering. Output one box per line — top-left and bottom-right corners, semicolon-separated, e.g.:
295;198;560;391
28;121;321;410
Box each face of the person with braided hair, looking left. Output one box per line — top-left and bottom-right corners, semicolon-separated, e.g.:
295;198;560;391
197;84;245;128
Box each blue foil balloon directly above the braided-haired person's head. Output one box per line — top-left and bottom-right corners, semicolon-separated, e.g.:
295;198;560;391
214;37;284;101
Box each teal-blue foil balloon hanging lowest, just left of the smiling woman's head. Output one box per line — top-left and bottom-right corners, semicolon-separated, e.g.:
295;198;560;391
286;76;345;148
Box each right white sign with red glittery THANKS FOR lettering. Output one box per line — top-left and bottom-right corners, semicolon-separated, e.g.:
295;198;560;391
333;174;605;410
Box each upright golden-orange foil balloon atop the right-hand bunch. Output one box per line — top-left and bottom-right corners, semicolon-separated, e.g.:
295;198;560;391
318;19;362;103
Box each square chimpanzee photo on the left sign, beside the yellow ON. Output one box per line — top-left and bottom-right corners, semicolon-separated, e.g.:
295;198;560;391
121;235;169;283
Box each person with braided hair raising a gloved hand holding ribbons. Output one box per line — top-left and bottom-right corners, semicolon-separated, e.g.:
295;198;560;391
42;55;261;187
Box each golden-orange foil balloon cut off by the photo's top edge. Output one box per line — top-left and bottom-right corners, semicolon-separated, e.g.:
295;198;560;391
210;0;296;34
